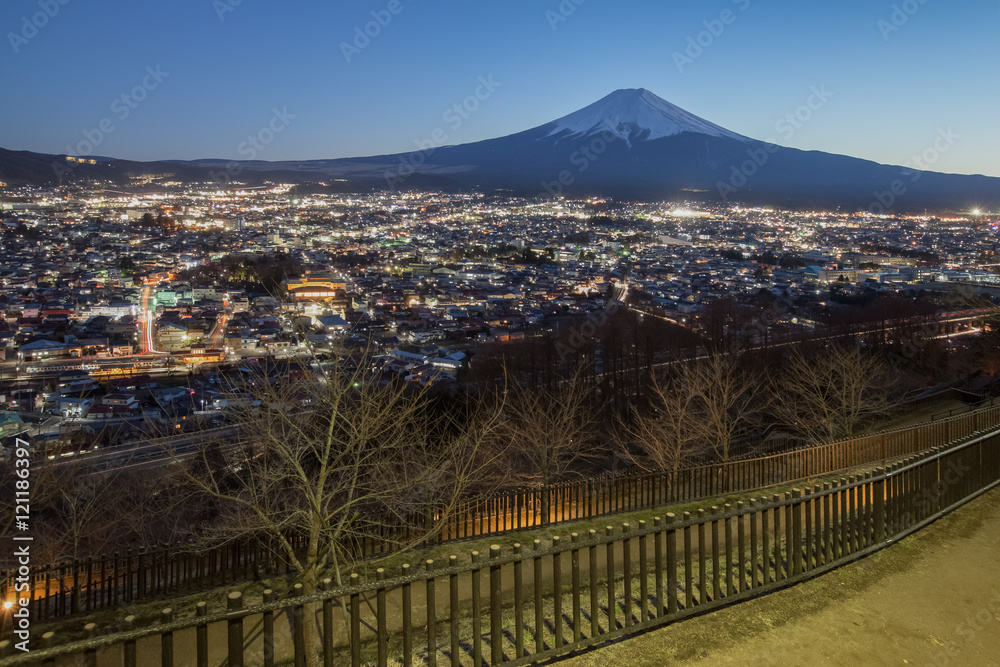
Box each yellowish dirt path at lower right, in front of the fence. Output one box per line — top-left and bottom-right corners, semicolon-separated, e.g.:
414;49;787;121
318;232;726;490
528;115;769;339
560;490;1000;667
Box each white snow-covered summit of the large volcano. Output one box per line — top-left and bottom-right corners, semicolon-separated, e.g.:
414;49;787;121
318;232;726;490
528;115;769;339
548;88;752;145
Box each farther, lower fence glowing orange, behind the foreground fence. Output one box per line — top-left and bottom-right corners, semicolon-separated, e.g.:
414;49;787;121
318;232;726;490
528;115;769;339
0;406;1000;621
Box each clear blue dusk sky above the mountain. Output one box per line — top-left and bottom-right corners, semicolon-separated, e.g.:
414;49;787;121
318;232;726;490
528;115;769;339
0;0;1000;176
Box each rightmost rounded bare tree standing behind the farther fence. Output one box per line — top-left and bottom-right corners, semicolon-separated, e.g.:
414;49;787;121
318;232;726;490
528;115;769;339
770;344;898;442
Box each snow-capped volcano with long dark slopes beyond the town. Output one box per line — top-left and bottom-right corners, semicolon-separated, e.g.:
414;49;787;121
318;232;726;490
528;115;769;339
0;89;1000;212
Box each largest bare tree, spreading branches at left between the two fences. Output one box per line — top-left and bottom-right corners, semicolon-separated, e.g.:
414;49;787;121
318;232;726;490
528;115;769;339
174;366;508;590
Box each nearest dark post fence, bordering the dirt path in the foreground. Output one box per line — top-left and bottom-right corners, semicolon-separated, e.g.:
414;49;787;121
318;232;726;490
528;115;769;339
0;430;1000;667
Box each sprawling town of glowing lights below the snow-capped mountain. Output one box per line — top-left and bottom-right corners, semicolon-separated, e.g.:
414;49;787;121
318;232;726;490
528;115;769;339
0;176;1000;453
